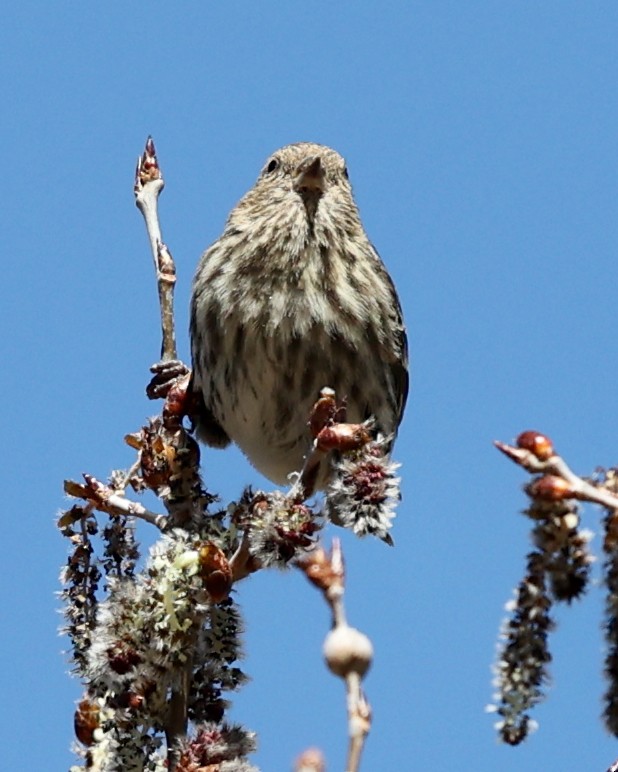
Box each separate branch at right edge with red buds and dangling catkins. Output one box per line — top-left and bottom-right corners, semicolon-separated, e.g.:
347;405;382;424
489;431;618;745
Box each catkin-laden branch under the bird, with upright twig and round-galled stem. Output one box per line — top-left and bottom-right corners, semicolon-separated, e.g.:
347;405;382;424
59;137;400;772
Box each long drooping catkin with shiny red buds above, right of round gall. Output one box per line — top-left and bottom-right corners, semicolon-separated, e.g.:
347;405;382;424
489;431;594;745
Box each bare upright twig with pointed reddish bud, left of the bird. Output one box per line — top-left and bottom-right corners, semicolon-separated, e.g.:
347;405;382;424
133;137;177;361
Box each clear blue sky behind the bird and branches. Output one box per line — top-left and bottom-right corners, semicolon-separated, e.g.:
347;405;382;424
0;0;618;772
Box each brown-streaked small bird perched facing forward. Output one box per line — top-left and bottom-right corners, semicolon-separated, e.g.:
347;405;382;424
190;142;408;488
